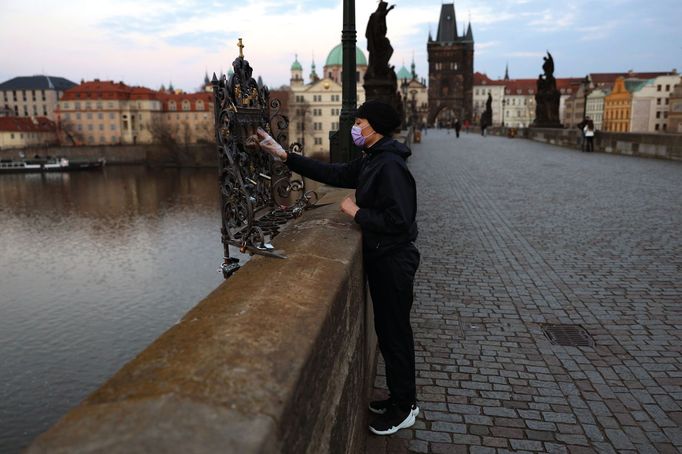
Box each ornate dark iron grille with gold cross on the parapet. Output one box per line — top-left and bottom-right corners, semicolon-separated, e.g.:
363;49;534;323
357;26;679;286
212;38;317;279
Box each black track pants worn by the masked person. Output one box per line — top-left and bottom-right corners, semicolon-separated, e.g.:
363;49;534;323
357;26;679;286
365;244;419;407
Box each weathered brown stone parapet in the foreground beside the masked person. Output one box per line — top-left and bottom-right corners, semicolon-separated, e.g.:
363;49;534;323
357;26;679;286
27;190;376;454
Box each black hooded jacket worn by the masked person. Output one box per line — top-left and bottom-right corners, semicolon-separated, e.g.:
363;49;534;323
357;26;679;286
286;137;417;259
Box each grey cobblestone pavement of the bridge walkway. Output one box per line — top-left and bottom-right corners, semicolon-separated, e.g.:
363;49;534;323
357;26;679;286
367;130;682;454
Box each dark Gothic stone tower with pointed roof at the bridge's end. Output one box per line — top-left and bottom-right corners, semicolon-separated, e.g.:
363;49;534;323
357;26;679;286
426;3;474;126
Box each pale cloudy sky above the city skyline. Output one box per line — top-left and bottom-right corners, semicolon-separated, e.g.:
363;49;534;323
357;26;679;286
0;0;682;91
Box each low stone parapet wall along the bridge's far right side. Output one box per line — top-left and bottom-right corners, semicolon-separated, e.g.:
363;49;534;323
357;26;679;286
489;128;682;160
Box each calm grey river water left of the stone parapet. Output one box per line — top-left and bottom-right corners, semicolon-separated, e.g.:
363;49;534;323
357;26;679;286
0;167;244;453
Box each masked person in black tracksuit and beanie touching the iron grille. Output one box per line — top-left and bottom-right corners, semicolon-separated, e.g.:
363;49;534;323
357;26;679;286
259;101;419;435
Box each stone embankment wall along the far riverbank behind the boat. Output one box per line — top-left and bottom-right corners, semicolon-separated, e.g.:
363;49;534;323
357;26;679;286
0;144;218;168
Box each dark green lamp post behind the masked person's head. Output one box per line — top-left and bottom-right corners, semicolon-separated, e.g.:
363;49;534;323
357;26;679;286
329;0;358;162
